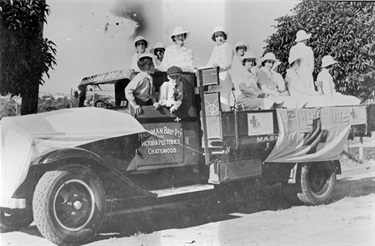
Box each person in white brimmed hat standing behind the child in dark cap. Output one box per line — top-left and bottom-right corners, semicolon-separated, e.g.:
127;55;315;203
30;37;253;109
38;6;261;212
161;27;194;71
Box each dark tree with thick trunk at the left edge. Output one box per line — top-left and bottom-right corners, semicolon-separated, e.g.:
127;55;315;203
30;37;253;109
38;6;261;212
0;0;56;115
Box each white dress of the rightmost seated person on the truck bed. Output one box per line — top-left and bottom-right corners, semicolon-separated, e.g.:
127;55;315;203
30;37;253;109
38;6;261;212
317;68;360;105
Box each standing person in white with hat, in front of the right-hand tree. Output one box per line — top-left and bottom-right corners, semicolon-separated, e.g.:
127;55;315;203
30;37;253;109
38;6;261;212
289;30;315;90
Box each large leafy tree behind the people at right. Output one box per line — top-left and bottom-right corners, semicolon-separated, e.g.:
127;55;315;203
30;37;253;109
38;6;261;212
265;0;375;98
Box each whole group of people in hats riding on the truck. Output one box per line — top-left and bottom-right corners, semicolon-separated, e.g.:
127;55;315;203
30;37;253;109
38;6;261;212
125;26;360;114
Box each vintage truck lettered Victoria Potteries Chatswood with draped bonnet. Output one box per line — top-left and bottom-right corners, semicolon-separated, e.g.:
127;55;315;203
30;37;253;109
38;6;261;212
0;68;375;244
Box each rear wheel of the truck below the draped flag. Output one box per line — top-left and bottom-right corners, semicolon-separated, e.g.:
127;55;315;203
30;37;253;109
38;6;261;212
283;162;336;205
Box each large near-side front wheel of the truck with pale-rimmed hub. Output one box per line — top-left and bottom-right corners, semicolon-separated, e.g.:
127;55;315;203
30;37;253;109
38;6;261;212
33;165;105;244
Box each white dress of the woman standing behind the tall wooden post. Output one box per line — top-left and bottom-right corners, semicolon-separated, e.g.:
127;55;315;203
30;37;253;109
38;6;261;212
206;43;234;110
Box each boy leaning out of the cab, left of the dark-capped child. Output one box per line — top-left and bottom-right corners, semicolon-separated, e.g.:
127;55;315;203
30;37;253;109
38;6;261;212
125;54;159;115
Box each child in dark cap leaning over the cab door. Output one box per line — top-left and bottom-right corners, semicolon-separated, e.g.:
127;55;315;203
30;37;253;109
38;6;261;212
159;66;184;113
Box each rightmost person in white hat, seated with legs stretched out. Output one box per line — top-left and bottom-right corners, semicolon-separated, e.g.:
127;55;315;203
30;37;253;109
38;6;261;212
316;55;360;105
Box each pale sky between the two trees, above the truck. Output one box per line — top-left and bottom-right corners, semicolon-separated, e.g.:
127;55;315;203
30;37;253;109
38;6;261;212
40;0;300;93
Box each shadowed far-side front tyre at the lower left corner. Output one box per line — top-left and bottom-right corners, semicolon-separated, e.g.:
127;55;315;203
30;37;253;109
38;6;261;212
0;208;33;233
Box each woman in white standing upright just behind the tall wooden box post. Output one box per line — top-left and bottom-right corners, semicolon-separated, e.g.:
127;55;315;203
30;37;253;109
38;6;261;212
206;26;234;110
